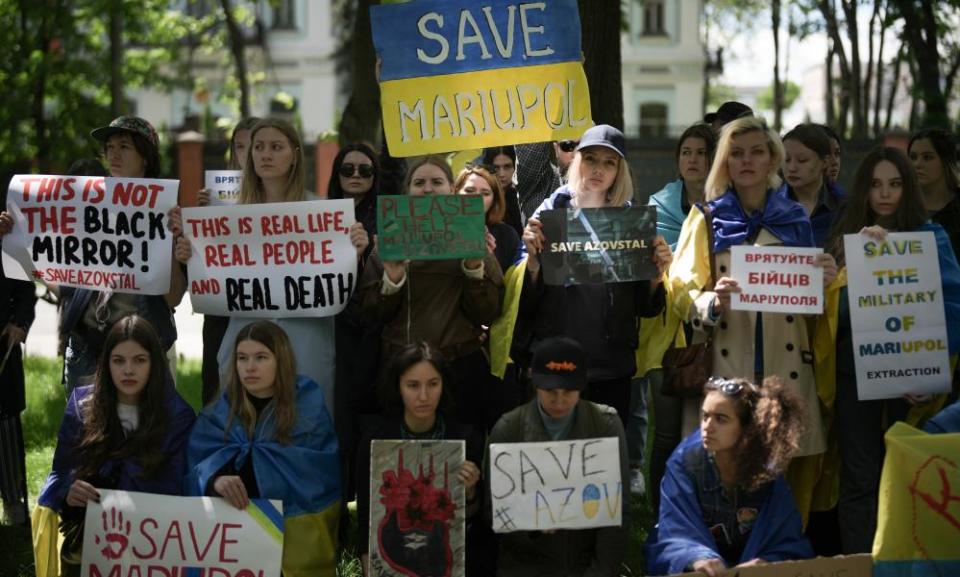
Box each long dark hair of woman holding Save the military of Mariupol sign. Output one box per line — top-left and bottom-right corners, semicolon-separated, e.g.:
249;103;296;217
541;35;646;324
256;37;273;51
827;146;927;266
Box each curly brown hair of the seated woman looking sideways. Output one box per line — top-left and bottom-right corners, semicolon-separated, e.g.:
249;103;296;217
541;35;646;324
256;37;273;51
704;376;806;491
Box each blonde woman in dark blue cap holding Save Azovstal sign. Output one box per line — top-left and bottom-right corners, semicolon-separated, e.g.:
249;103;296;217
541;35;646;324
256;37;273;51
518;124;672;423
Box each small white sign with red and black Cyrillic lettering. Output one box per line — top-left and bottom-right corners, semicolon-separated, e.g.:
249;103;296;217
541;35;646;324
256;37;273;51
730;245;823;314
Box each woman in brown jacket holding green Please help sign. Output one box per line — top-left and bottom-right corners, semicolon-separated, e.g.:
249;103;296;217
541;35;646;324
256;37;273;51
360;157;503;430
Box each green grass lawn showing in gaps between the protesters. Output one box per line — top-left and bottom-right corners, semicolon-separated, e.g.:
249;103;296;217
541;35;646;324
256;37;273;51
0;357;654;577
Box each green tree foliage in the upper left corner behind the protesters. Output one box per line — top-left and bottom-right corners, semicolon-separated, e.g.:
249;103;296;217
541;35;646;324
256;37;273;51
0;0;231;176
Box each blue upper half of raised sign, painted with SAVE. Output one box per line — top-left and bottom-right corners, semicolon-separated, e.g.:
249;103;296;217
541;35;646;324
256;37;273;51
370;0;580;82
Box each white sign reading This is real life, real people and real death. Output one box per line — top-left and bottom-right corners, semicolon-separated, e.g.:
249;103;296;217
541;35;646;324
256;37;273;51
183;200;357;318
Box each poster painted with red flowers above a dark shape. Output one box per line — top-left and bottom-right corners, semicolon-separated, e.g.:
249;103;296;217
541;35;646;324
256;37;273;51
370;440;466;577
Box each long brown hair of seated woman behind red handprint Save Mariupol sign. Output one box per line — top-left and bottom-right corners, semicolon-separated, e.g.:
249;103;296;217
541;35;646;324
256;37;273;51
77;315;173;478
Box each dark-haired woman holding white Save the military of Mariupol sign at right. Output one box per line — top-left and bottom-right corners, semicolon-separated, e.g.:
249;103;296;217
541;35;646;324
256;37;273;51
816;147;960;553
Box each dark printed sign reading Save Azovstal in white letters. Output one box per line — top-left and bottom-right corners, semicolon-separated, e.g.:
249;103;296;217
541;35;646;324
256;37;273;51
540;206;659;285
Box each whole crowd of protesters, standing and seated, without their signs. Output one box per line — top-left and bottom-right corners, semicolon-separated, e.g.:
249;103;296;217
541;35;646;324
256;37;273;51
0;102;960;577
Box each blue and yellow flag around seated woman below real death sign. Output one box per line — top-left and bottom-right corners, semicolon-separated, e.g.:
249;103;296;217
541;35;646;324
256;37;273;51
185;376;341;577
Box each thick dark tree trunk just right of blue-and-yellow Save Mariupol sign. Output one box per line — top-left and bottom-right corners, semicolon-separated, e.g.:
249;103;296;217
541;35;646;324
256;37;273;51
577;0;623;130
